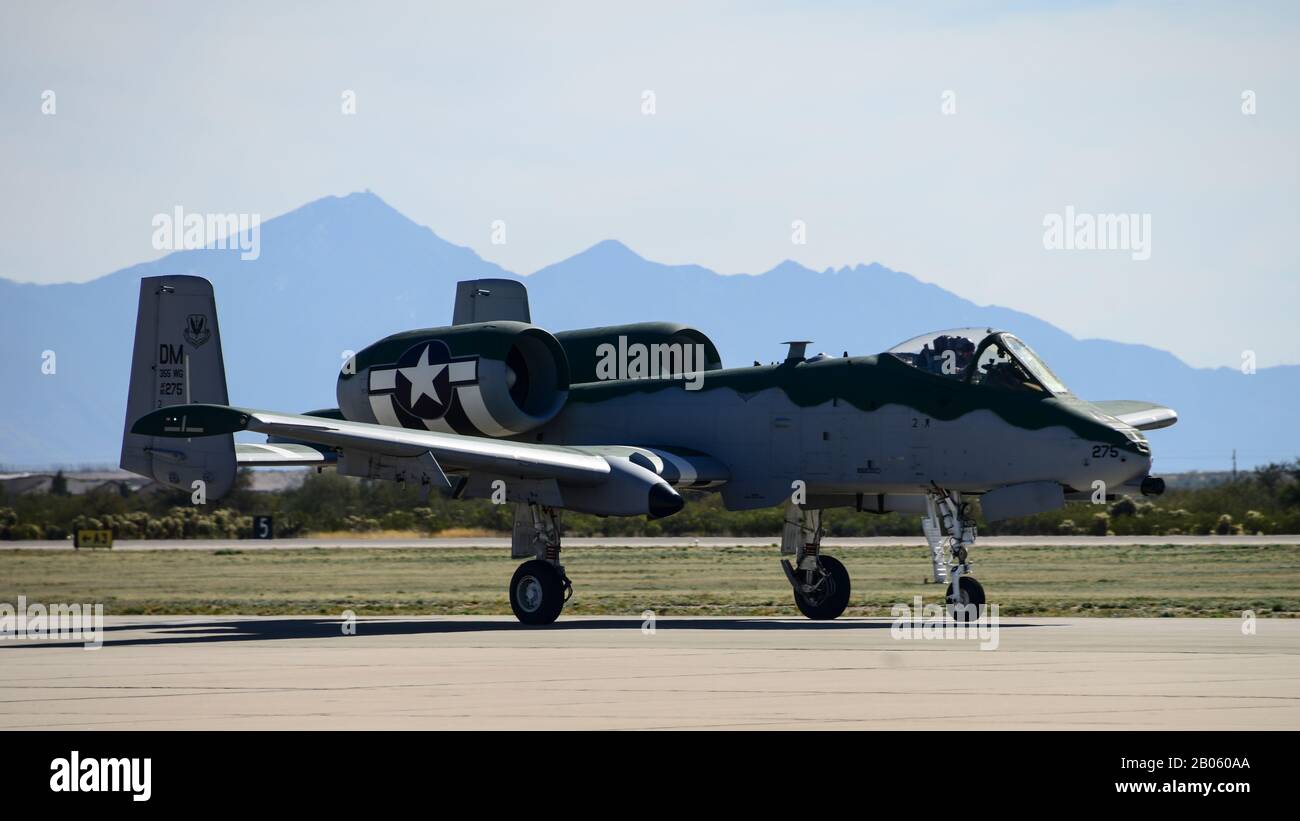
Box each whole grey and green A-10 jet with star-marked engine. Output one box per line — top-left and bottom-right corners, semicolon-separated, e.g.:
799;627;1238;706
121;275;1178;625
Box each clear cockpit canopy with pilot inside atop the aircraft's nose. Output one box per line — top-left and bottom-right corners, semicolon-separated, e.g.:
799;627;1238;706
887;327;1070;395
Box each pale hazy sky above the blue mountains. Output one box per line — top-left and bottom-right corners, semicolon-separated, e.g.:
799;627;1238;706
0;1;1300;366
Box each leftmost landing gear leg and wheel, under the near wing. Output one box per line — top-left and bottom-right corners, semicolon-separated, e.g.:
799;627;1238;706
510;503;573;625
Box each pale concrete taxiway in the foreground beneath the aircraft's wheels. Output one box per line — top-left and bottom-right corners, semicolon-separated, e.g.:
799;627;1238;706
0;617;1300;730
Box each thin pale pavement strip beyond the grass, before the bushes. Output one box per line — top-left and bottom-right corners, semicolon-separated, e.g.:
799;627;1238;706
0;535;1300;551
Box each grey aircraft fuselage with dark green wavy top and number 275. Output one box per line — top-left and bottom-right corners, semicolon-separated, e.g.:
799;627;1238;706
519;356;1151;509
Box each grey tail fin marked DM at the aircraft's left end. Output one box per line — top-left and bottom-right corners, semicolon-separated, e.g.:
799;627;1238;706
121;275;235;499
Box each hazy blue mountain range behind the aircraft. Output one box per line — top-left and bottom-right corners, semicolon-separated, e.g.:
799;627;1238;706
0;192;1300;473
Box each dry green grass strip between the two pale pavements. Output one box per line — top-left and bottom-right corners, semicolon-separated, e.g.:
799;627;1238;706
0;539;1300;617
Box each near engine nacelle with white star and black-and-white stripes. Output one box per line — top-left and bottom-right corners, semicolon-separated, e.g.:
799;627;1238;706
337;321;569;436
